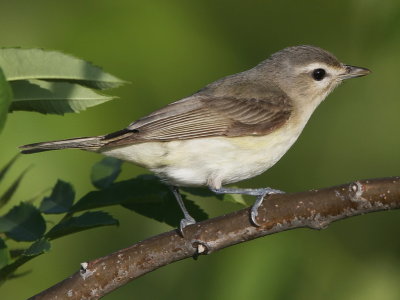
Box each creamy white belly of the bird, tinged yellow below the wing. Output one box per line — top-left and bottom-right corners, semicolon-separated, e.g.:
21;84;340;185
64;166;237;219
102;124;298;188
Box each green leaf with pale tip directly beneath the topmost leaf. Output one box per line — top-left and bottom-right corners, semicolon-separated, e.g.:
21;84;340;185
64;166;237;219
10;79;114;115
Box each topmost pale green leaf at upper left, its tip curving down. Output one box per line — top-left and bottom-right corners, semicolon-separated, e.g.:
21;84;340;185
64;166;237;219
0;48;126;90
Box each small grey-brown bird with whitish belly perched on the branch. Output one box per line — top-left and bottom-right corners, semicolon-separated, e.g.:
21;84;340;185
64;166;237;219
21;45;370;233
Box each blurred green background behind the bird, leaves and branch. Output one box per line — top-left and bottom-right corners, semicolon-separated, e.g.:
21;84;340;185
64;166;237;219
0;0;400;300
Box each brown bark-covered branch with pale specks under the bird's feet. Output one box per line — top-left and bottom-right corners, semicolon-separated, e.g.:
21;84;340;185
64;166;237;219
31;177;400;299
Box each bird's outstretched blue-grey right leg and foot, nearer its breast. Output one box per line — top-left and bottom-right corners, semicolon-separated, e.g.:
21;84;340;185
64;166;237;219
210;187;285;226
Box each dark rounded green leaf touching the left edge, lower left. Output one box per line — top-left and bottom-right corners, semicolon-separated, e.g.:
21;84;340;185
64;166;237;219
0;202;46;242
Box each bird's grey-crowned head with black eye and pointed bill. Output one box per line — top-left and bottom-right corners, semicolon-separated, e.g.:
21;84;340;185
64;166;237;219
255;45;370;105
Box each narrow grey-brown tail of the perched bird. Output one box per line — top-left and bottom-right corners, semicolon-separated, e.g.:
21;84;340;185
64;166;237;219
19;136;103;154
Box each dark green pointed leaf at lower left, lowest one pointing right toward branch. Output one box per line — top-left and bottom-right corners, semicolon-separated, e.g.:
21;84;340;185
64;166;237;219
46;211;119;239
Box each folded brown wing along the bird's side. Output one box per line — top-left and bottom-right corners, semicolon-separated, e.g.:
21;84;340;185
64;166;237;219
104;83;293;147
